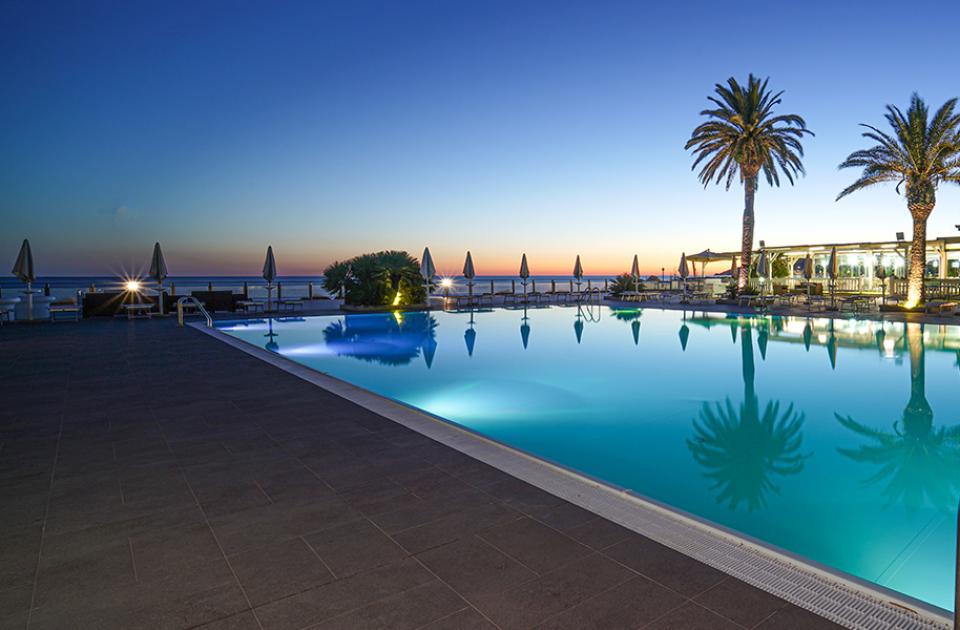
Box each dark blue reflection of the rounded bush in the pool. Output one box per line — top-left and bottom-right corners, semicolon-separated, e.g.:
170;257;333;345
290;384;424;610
323;312;437;367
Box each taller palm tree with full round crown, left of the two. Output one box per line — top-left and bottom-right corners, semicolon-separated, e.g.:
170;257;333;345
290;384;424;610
684;74;813;291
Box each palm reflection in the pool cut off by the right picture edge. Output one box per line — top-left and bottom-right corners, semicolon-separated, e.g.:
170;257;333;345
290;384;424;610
835;324;960;512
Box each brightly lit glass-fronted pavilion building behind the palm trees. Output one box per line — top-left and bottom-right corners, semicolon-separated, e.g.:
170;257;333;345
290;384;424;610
716;236;960;290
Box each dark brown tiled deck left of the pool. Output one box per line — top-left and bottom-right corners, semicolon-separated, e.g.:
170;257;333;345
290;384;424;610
0;321;834;630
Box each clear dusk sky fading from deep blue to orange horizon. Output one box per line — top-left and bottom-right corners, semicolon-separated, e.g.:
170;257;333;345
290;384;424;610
0;0;960;275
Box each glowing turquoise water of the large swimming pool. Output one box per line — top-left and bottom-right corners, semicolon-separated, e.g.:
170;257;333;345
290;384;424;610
218;307;960;609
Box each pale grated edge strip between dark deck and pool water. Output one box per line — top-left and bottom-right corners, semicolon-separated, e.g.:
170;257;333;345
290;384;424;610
189;314;952;630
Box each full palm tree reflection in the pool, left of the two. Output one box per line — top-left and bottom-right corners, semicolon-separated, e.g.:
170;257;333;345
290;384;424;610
687;321;808;512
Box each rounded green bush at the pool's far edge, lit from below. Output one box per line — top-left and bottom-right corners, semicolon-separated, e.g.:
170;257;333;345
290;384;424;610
323;250;427;306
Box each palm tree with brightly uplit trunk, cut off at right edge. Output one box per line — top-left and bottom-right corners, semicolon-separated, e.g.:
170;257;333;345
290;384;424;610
837;94;960;308
